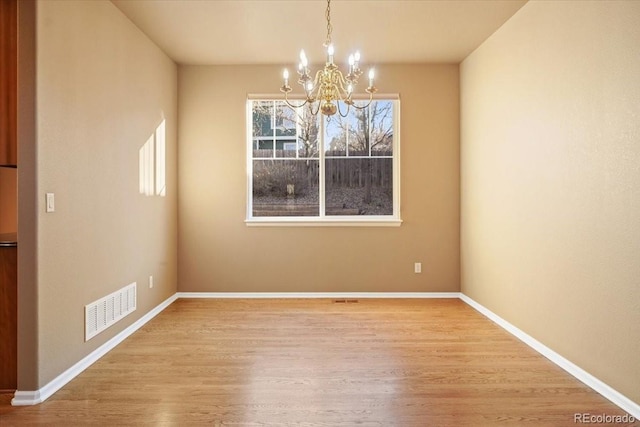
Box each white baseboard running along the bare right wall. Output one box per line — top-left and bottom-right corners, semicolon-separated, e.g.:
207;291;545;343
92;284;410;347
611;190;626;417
460;293;640;419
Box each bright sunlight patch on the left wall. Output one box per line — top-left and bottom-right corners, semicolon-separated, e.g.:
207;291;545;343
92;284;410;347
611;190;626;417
138;120;167;197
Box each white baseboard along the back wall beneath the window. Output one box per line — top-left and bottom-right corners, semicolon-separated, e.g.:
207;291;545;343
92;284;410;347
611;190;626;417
177;292;460;299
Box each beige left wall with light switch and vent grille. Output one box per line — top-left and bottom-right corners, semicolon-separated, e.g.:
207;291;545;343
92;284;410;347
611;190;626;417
18;1;177;391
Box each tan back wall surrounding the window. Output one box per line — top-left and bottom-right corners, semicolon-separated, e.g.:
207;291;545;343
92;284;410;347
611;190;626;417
178;65;460;292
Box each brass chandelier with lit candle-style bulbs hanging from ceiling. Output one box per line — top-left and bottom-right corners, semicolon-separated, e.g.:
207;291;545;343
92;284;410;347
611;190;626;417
280;0;378;117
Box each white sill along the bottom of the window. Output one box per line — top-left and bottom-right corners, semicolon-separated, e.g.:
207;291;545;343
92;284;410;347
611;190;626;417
245;217;402;227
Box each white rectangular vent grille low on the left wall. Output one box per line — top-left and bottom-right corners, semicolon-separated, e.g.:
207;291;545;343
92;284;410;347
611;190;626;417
84;282;136;341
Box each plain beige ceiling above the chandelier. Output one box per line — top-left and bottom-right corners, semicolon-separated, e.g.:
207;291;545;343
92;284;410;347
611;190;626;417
112;0;526;64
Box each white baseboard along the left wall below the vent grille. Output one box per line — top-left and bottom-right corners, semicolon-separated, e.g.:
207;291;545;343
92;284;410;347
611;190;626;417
11;294;178;406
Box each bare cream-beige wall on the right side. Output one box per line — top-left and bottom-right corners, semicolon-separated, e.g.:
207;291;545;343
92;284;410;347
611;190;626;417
461;1;640;403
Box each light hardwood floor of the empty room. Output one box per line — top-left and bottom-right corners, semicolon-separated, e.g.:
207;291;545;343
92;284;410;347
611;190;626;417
0;299;636;427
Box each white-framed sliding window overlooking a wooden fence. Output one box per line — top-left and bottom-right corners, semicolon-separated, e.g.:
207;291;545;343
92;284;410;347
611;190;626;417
247;98;400;225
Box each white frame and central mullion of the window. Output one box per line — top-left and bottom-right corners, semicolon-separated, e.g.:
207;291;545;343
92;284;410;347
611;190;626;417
245;94;402;227
